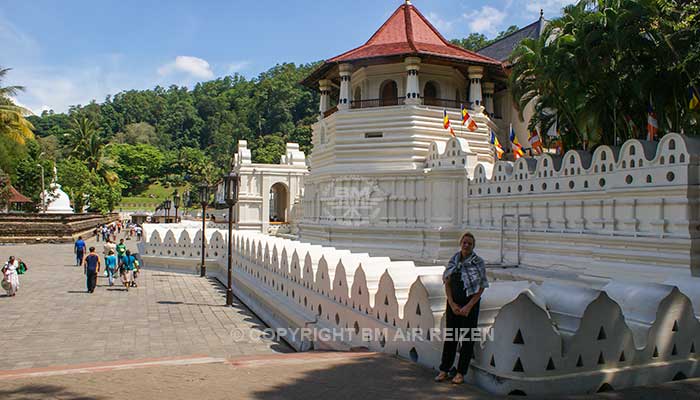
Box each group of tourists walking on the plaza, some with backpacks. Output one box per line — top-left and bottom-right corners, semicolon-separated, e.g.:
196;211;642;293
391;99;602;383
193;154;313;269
74;233;139;293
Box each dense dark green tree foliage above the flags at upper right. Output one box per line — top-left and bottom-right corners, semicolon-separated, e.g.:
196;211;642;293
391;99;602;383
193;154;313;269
509;0;700;147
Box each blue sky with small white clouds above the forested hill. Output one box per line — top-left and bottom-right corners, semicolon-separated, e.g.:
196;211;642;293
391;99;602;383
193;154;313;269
0;0;574;113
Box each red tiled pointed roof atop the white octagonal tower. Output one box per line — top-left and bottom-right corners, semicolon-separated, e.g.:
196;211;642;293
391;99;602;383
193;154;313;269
326;4;500;65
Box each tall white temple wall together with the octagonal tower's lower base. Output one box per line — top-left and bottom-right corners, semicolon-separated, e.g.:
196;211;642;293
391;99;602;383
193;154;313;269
301;134;700;281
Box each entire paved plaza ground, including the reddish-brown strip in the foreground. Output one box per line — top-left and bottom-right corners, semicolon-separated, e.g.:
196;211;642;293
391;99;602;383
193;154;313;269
0;241;700;400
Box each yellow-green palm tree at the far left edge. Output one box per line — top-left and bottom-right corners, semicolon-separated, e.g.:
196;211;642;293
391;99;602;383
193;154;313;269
0;68;34;144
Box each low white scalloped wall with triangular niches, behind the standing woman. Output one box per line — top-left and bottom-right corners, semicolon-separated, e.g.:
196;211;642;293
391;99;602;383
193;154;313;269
140;225;700;395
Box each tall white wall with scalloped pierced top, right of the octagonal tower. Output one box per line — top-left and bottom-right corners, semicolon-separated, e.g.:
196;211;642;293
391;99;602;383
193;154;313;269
462;134;700;276
